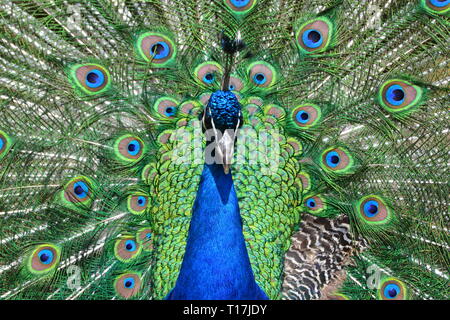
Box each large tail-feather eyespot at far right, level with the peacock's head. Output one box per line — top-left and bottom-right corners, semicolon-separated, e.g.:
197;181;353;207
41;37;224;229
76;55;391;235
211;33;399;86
379;80;423;112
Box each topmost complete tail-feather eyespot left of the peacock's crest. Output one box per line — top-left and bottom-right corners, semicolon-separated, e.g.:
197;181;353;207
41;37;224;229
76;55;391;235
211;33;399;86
136;32;176;66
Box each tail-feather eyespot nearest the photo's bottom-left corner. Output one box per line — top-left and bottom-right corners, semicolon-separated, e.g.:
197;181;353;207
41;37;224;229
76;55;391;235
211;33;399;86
28;244;60;274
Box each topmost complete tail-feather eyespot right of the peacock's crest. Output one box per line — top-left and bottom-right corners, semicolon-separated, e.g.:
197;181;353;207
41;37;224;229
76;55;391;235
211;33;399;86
296;17;333;54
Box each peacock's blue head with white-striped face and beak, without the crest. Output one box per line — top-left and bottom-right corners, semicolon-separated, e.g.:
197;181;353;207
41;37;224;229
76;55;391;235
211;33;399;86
200;90;243;174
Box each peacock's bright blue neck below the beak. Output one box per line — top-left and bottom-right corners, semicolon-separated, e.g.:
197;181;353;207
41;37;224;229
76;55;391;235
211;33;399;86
167;164;268;300
